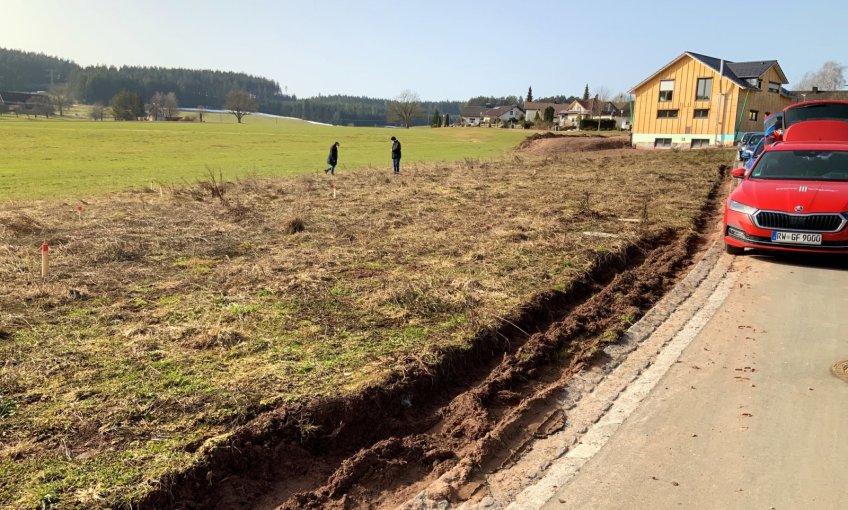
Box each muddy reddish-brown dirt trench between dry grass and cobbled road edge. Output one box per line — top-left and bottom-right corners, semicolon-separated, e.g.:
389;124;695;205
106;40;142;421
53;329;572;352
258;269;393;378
141;163;725;509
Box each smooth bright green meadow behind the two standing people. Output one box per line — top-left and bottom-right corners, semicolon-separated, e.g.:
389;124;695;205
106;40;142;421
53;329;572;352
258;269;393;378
0;116;528;201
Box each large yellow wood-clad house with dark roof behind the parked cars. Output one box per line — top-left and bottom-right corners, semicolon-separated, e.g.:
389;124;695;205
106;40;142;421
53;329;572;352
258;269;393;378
630;51;794;148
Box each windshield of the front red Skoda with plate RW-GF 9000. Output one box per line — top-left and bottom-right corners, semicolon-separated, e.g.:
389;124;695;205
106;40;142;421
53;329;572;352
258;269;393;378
751;150;848;181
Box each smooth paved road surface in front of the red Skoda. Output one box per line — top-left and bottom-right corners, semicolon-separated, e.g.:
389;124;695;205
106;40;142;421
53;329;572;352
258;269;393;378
543;254;848;509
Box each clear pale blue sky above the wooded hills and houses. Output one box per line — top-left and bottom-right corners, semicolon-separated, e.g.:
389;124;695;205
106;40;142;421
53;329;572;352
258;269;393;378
0;0;848;100
